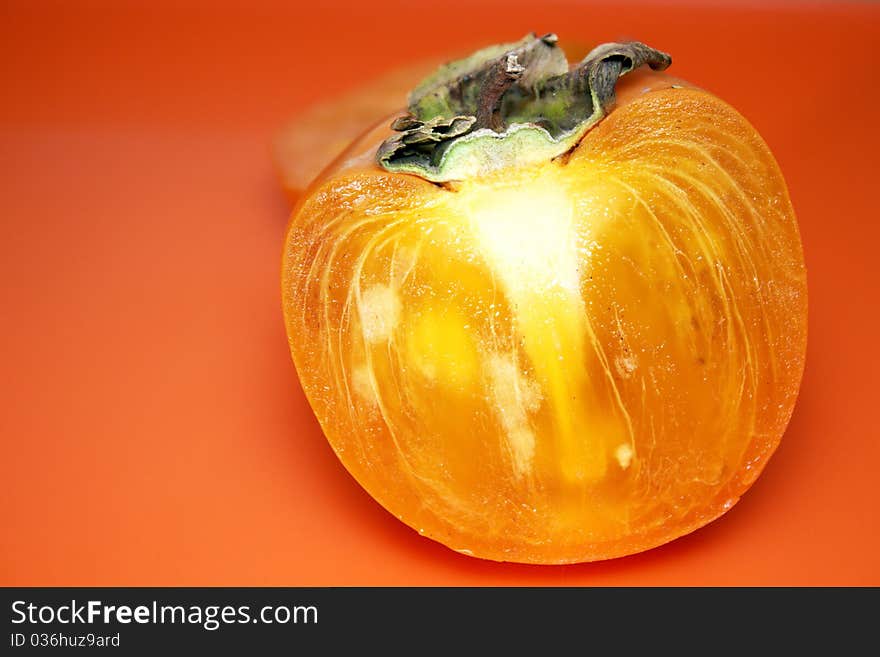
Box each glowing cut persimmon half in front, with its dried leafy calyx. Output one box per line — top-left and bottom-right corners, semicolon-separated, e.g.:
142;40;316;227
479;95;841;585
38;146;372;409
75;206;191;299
282;35;807;564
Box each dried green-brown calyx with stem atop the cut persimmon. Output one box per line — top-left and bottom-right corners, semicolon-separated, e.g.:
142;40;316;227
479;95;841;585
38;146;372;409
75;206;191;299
376;34;672;182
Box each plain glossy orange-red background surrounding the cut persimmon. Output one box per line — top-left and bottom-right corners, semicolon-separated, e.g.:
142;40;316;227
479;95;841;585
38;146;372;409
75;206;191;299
0;0;880;585
